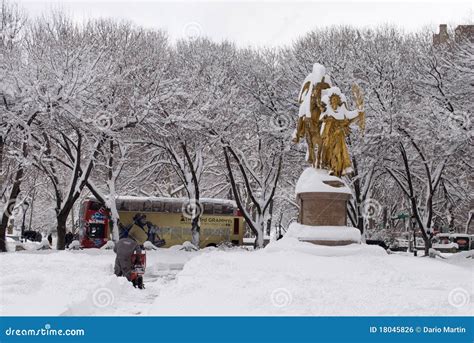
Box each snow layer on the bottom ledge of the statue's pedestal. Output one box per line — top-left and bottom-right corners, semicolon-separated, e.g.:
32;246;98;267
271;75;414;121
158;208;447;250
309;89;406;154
285;222;360;243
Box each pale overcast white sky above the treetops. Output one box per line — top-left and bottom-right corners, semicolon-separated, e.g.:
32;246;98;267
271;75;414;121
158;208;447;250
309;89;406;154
14;0;474;46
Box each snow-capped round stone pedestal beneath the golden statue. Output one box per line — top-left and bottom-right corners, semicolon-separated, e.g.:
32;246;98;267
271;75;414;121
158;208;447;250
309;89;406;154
294;168;360;246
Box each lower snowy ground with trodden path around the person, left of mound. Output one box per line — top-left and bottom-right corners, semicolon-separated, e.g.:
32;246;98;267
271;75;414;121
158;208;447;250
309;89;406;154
0;249;201;316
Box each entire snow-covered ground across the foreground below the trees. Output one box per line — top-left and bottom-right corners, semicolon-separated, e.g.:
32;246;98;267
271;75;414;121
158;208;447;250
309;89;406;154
0;238;474;316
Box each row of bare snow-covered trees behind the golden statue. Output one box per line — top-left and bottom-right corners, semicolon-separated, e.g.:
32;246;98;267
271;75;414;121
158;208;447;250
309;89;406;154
0;2;473;251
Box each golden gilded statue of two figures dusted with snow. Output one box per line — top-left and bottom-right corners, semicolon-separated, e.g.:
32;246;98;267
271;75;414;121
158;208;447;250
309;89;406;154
293;63;365;176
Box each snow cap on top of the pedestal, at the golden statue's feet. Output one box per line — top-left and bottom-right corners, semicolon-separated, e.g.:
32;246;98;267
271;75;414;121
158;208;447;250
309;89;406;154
295;167;352;194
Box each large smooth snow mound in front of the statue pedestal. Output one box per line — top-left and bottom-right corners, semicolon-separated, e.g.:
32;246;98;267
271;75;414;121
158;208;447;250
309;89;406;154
149;238;473;316
